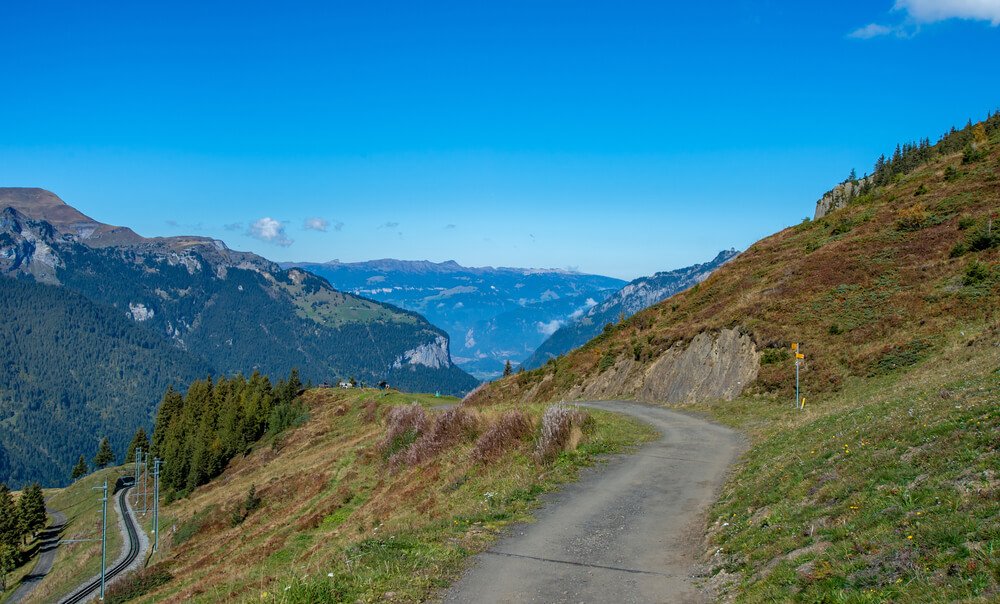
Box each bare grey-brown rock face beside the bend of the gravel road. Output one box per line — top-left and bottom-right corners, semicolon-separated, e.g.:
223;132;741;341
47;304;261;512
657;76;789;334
523;329;760;403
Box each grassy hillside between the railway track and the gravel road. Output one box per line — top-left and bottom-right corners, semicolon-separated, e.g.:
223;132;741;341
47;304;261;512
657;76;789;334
125;389;654;602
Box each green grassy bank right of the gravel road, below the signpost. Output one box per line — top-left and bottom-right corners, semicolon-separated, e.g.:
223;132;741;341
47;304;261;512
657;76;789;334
686;322;1000;603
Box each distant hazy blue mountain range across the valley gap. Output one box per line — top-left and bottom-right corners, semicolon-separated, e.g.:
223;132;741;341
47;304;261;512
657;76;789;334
282;259;625;379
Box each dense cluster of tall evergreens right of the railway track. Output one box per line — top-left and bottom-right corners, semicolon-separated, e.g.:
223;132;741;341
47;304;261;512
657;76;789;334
152;369;305;493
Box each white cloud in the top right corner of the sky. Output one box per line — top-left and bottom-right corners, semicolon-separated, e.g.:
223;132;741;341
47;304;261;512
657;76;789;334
847;0;1000;40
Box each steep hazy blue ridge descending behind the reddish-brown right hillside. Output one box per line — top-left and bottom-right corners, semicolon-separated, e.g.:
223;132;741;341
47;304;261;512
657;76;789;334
524;249;739;369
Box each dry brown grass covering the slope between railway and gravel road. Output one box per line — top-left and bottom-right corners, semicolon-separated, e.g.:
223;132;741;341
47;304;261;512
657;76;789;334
129;390;652;602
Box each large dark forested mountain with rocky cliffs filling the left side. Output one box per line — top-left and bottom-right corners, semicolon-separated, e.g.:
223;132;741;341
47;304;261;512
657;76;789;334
0;188;477;485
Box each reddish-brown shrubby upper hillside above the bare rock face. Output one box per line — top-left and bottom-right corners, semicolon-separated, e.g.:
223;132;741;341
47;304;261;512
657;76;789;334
476;116;1000;403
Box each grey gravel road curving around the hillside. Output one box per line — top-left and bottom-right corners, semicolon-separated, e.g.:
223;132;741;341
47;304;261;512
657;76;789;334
442;402;742;604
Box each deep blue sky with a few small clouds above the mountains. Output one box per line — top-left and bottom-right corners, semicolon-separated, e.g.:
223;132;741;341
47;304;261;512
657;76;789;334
0;0;1000;278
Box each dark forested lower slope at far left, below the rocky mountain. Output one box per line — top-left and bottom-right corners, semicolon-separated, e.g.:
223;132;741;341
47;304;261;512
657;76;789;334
0;279;210;485
